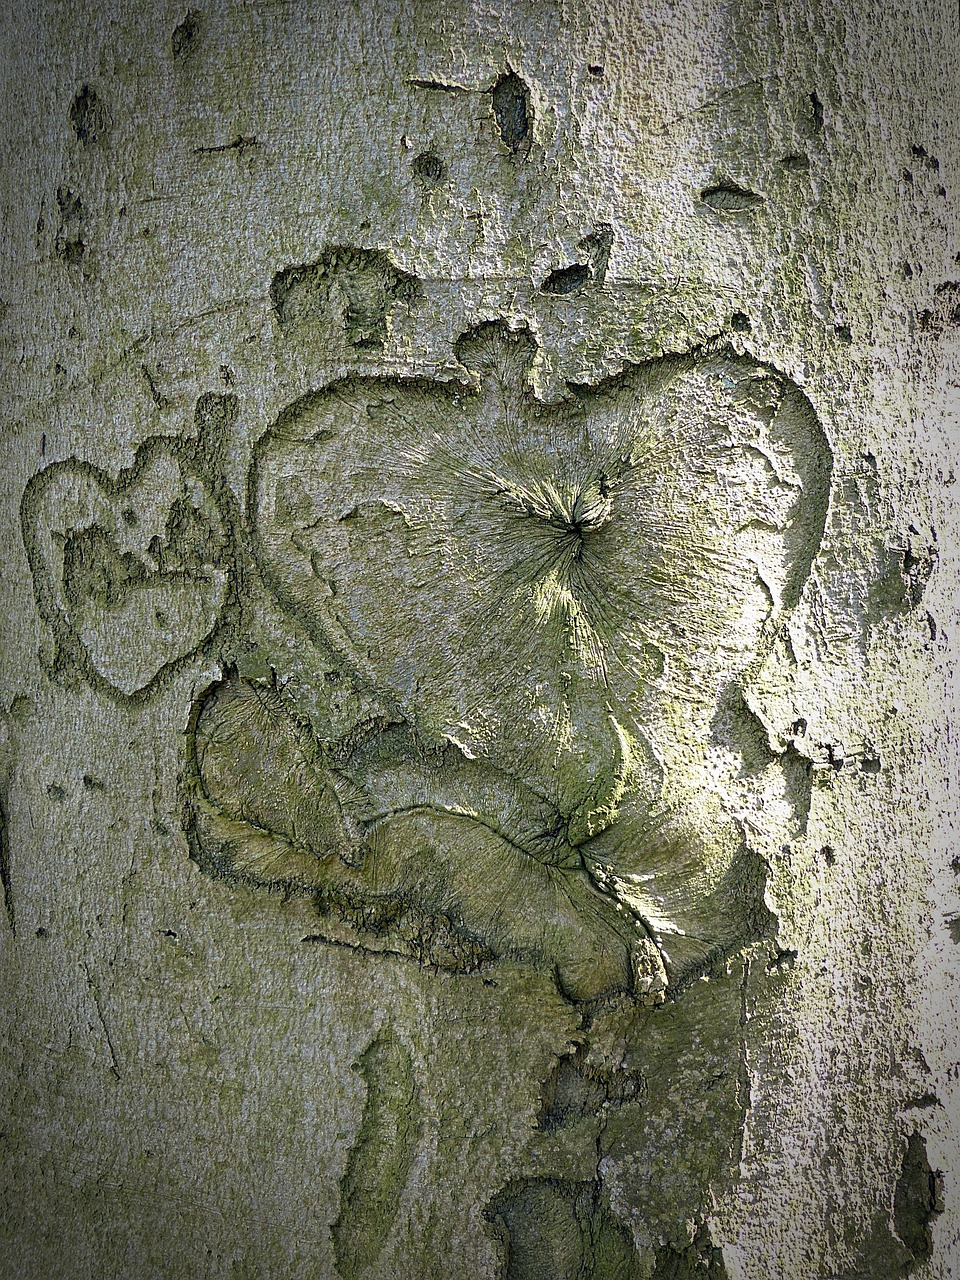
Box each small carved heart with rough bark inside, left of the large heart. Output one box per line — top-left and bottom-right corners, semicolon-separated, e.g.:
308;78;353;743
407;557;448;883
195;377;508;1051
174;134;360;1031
22;438;230;696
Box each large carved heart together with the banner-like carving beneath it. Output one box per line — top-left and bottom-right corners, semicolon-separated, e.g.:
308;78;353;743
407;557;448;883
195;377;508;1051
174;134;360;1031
179;324;829;1000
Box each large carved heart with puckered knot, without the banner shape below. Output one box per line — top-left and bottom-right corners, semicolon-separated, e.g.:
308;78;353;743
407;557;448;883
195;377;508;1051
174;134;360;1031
251;324;828;826
